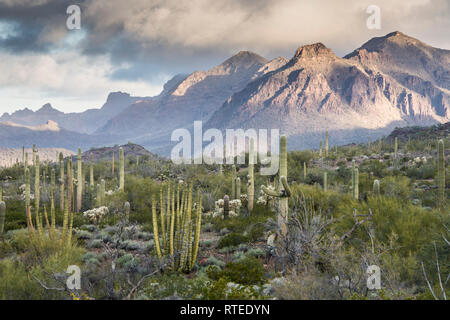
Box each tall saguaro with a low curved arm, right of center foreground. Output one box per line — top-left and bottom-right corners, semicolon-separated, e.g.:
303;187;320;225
261;136;292;237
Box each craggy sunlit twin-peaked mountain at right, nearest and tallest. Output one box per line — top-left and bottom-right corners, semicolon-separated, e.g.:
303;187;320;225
207;32;450;147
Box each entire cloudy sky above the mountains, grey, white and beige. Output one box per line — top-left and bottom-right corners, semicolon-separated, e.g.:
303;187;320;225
0;0;450;112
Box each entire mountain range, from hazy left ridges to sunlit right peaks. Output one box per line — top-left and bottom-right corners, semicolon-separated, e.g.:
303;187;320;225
0;32;450;154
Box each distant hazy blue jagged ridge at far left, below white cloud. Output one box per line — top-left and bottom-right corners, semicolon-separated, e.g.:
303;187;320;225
0;92;145;133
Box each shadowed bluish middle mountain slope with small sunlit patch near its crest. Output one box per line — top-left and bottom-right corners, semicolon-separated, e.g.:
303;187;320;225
97;51;268;141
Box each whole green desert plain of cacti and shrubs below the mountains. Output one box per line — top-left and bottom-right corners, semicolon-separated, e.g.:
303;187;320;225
0;129;450;299
